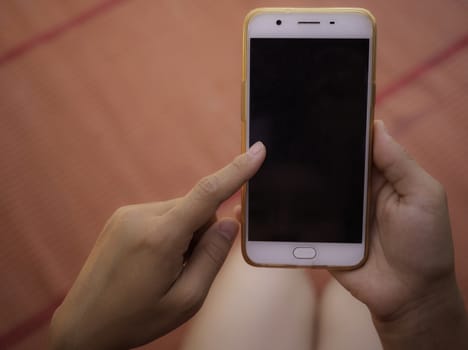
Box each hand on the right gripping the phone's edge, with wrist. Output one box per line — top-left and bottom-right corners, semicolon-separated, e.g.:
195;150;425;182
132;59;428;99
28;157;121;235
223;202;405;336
331;121;468;350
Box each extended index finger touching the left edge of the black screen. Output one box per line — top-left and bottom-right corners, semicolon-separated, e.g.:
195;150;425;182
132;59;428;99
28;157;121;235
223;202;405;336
166;142;266;233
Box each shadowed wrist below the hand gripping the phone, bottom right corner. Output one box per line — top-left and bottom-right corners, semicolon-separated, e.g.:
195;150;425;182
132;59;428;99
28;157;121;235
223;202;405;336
373;276;468;350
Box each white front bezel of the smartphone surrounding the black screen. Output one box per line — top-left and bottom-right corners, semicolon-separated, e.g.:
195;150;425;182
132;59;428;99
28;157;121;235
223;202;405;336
243;9;375;268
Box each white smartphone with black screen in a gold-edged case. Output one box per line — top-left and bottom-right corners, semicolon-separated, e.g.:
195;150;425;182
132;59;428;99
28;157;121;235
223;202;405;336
242;8;376;269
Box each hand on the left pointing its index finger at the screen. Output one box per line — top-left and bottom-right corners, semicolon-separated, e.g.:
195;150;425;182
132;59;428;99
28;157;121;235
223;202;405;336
51;143;265;349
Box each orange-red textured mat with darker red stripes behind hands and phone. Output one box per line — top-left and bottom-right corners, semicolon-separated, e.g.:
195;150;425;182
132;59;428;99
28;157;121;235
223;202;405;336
0;0;468;349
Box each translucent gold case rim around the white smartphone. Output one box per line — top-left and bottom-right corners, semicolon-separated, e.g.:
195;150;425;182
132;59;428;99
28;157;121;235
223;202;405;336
241;7;377;270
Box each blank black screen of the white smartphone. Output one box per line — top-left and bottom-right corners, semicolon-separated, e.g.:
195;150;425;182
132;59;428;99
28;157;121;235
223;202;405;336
248;38;369;243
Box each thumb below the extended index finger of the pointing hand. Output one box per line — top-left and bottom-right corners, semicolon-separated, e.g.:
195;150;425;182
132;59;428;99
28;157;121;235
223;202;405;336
163;218;239;313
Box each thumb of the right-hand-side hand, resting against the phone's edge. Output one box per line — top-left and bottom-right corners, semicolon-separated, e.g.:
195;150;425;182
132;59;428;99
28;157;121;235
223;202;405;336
374;120;433;196
